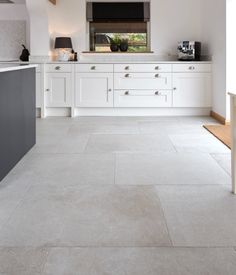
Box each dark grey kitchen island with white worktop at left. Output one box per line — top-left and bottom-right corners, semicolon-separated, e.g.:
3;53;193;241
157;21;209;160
0;65;36;181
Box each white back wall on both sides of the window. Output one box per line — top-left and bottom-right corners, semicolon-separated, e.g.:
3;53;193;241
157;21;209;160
48;0;205;55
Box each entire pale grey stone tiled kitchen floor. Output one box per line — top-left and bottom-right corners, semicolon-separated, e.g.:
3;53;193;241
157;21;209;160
0;117;236;275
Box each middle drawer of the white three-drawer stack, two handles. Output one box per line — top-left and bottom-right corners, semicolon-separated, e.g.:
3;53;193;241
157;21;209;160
114;73;172;90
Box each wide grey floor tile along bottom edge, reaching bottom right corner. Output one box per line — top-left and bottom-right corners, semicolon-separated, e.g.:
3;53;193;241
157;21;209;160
43;248;236;275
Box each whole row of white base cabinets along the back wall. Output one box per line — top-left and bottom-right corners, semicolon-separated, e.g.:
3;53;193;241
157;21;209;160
2;61;212;118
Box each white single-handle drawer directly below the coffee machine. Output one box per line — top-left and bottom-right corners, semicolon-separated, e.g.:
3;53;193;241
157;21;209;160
173;63;211;73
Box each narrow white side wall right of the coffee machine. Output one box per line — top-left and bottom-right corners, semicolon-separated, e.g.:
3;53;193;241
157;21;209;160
202;0;227;118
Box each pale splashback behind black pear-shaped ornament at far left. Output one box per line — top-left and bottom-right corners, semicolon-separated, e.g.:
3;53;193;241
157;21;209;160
0;20;26;61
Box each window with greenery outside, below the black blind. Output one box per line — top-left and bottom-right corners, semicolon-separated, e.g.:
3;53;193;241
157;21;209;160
90;22;150;52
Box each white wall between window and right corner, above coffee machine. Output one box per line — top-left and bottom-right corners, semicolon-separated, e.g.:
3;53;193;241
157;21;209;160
151;0;202;55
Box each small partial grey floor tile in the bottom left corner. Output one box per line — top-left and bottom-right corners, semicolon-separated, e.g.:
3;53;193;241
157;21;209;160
0;248;48;275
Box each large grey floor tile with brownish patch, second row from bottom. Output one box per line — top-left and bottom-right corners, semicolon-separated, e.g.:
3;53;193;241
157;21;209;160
0;185;171;247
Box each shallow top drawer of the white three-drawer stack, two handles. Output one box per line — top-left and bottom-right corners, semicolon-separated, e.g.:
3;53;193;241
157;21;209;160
114;64;172;73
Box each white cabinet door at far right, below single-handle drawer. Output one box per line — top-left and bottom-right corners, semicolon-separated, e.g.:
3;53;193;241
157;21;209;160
173;73;211;108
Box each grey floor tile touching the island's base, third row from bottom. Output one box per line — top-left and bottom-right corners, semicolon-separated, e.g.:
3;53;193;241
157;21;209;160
8;153;115;187
